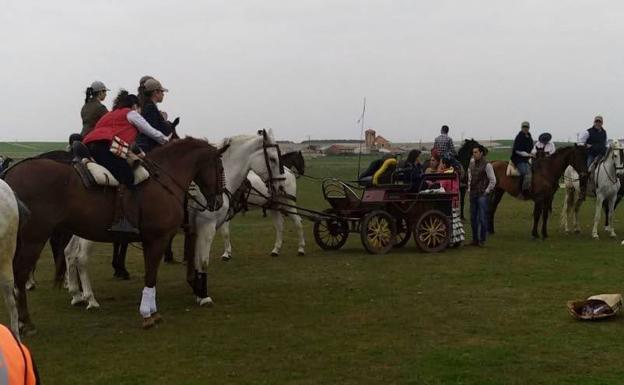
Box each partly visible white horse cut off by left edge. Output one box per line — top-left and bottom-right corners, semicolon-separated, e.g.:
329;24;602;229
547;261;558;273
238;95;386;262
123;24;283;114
0;179;20;336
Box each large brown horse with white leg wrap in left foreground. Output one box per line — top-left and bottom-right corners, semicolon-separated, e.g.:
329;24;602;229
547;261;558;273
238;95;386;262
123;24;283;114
5;138;225;333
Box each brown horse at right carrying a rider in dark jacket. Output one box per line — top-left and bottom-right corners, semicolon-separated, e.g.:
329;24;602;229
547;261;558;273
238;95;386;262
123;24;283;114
489;145;587;238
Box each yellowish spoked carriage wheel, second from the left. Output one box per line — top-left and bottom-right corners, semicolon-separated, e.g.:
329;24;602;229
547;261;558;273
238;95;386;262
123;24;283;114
360;210;396;254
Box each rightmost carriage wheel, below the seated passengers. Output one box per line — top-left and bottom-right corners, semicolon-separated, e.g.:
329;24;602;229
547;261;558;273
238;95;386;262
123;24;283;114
414;210;451;253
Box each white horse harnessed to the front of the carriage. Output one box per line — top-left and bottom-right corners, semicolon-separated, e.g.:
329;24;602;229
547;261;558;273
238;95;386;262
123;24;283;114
221;168;305;260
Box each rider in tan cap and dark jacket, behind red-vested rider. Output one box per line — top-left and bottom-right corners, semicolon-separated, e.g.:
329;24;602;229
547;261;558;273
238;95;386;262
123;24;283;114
137;78;173;153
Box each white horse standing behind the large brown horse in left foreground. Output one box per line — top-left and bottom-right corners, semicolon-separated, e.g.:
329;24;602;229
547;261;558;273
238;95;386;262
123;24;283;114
65;130;282;309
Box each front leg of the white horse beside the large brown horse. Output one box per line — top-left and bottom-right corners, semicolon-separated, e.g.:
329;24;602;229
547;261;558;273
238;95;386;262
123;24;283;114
194;220;217;306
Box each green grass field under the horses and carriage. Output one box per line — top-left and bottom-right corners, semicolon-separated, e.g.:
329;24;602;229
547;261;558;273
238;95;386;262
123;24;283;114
0;146;624;385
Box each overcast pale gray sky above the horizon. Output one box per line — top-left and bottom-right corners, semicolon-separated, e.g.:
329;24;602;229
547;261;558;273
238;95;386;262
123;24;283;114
0;0;624;142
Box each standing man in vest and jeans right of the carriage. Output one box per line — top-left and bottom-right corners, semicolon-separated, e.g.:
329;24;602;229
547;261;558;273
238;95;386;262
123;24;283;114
468;145;496;246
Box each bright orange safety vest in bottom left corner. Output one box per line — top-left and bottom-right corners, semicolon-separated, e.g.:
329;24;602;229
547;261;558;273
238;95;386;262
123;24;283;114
0;325;39;385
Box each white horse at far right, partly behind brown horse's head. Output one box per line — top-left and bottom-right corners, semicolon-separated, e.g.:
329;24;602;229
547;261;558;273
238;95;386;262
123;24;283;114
561;142;624;239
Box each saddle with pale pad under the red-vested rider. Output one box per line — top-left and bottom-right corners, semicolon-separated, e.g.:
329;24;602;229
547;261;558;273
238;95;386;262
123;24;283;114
71;142;150;188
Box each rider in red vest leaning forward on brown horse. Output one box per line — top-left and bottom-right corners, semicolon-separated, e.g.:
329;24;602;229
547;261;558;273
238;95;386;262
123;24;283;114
83;90;169;233
